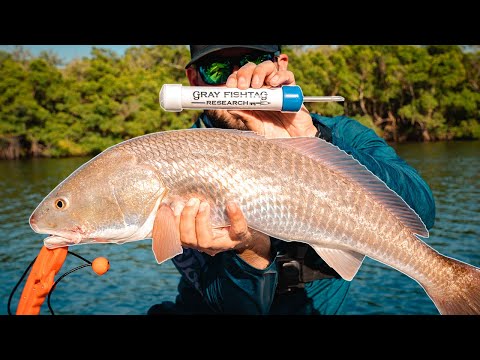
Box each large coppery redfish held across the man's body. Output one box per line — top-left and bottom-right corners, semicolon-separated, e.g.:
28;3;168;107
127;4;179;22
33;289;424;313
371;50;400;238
30;129;480;314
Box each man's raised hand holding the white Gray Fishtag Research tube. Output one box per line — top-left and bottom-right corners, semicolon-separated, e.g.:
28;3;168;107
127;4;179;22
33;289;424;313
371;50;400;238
226;55;317;138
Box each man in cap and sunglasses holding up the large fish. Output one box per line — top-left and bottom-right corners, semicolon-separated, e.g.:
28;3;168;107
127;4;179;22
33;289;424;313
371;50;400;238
148;45;435;315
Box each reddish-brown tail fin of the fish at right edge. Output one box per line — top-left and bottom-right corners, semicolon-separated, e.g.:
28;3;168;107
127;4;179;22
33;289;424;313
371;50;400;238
425;257;480;315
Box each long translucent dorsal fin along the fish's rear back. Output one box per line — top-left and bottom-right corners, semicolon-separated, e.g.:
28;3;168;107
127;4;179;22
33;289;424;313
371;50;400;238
268;137;428;237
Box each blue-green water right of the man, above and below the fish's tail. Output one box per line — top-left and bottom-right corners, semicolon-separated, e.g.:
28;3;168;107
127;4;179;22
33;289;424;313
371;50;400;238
345;141;480;315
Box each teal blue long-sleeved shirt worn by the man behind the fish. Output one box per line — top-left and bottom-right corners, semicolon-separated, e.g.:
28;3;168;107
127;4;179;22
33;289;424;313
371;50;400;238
148;114;435;315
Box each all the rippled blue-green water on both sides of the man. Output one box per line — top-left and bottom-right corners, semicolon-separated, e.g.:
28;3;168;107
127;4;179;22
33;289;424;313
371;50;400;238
0;141;480;315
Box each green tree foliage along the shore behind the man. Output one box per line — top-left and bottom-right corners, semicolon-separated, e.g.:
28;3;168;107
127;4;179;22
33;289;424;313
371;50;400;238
0;45;480;156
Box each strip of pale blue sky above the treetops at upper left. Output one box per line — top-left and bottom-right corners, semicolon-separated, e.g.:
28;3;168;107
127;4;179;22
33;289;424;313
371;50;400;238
0;45;137;63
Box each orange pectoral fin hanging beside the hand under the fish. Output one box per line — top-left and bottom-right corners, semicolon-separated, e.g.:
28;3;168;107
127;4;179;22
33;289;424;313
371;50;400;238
152;204;183;264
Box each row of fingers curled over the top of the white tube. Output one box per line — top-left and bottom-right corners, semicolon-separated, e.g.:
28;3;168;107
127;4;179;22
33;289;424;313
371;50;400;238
226;61;295;90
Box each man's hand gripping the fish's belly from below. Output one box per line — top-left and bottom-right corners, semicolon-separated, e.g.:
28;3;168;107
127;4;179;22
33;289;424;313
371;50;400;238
156;198;270;269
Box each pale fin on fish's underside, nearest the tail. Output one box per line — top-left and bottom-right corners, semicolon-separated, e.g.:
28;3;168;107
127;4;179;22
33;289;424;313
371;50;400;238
311;245;365;281
